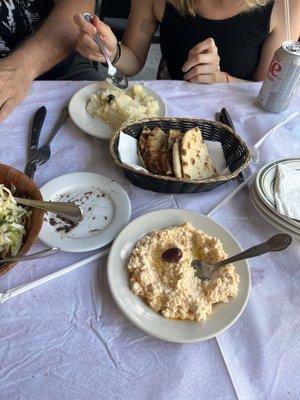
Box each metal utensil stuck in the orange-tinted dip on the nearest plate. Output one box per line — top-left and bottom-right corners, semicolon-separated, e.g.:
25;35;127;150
191;233;293;281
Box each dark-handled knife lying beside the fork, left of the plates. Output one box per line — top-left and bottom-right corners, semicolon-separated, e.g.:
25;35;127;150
24;106;47;179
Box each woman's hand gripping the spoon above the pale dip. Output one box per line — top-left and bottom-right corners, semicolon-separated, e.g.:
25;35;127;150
74;14;117;63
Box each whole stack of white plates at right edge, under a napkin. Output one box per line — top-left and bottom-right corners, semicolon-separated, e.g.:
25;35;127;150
250;158;300;239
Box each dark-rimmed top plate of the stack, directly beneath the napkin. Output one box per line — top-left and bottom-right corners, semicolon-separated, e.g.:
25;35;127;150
255;158;300;229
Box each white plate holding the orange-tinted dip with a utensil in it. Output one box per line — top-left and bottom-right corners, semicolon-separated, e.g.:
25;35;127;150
107;209;251;343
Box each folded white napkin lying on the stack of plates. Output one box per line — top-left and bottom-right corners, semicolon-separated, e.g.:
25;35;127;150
274;164;300;220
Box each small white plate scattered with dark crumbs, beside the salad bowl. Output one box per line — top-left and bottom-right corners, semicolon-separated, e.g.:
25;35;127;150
39;172;131;252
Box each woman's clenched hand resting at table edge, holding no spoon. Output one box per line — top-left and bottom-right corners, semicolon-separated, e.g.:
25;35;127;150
182;38;227;83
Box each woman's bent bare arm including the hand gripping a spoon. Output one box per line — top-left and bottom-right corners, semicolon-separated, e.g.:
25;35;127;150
75;0;157;76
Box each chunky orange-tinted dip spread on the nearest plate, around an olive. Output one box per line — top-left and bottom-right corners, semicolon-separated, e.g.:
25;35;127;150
127;223;239;322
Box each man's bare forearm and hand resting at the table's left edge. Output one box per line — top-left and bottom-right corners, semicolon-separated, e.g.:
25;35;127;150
0;0;95;122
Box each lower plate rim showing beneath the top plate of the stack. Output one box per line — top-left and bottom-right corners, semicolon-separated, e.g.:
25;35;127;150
250;185;300;239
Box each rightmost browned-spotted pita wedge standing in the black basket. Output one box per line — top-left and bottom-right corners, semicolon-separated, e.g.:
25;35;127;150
180;128;216;180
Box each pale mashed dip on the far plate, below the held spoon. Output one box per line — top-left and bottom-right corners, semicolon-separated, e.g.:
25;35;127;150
86;85;159;131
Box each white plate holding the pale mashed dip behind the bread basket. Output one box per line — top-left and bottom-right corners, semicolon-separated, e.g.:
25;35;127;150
69;82;167;140
